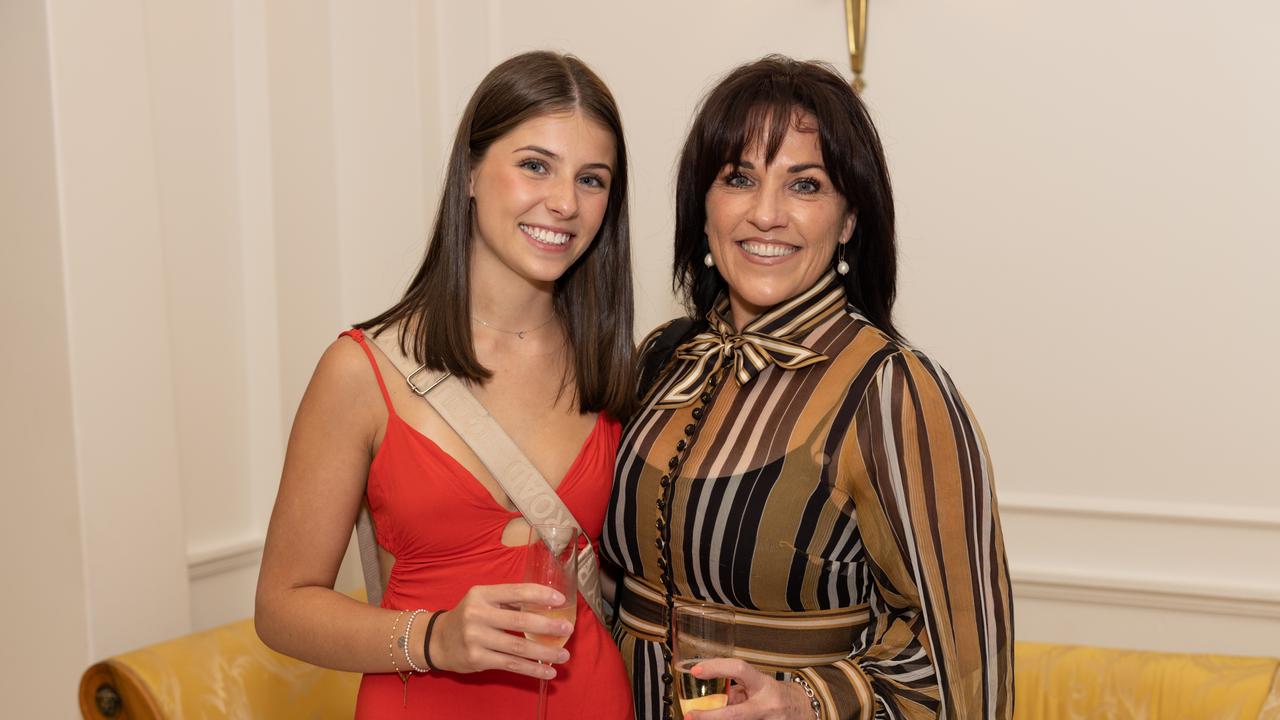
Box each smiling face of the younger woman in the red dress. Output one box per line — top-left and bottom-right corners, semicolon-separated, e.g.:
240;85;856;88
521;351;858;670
471;111;614;287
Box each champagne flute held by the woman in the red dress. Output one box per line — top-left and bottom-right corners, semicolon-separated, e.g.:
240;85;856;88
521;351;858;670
521;525;580;720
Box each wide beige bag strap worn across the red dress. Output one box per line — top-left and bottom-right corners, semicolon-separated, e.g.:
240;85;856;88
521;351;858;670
356;328;605;623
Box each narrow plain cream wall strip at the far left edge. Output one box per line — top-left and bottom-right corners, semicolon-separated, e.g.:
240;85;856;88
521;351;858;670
0;0;91;717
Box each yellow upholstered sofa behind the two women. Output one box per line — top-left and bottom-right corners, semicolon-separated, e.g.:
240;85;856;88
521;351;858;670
79;620;1280;720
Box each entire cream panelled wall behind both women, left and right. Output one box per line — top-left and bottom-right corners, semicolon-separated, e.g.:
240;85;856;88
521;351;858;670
0;0;1280;716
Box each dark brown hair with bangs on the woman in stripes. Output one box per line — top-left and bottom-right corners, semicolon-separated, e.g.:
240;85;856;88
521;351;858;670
673;55;901;338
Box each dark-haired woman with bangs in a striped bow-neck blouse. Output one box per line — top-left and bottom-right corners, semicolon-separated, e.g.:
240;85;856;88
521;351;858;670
603;56;1012;720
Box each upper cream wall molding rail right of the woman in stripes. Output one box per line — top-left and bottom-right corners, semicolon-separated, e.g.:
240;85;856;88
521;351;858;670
998;491;1280;532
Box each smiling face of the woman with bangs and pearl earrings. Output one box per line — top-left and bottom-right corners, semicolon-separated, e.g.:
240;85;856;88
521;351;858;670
705;115;855;329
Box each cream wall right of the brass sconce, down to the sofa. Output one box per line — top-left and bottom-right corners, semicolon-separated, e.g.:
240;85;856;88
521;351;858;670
867;0;1280;655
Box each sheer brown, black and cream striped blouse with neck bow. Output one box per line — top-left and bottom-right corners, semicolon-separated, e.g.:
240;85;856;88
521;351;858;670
602;274;1014;719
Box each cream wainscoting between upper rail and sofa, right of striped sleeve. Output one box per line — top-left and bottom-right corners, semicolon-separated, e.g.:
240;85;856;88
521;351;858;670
1001;493;1280;655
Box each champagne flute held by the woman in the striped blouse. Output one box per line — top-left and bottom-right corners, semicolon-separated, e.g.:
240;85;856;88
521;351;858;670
672;603;733;714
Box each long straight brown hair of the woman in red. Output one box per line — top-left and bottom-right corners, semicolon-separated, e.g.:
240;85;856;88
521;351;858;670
356;51;634;418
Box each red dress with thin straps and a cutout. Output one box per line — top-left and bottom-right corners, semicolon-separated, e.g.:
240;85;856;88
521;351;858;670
343;331;632;720
